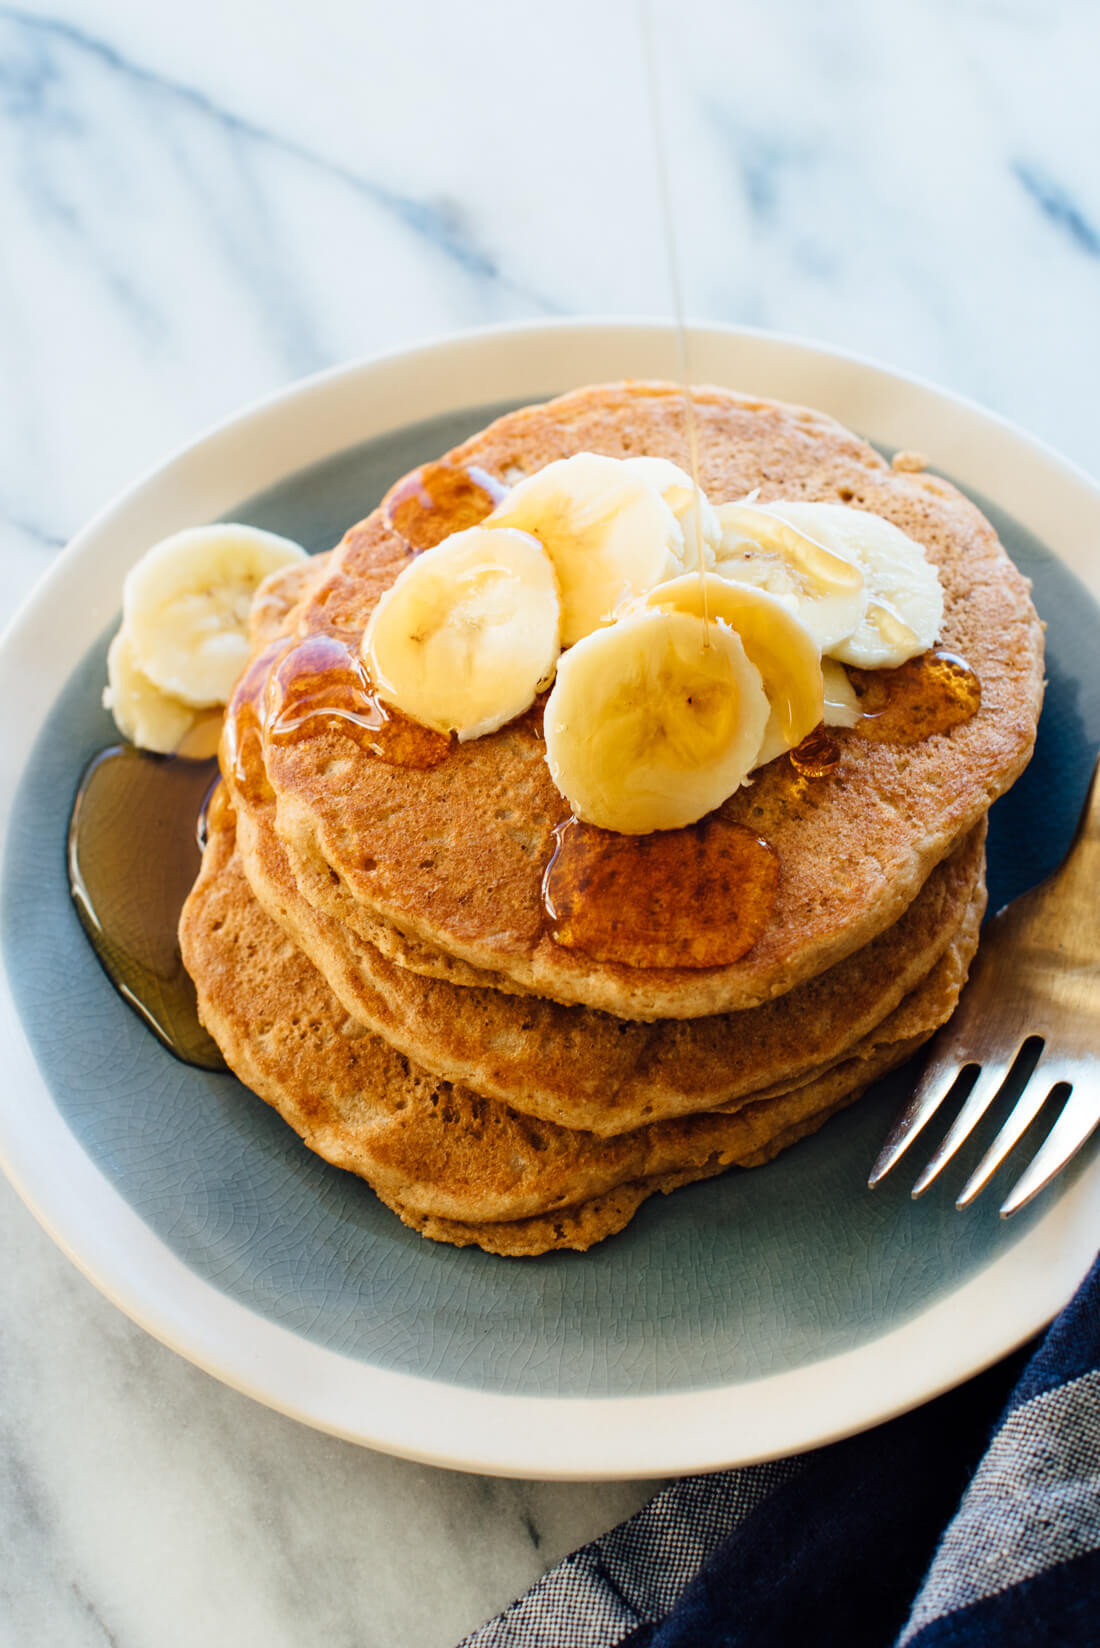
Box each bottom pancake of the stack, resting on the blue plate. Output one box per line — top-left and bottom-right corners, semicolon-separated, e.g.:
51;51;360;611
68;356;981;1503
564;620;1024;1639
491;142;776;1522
180;804;978;1254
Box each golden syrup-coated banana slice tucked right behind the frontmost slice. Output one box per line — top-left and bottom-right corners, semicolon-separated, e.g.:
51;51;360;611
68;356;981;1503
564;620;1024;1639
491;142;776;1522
635;572;825;766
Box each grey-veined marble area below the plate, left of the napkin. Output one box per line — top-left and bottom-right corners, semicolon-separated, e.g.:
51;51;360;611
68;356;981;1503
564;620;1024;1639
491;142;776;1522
0;1187;662;1648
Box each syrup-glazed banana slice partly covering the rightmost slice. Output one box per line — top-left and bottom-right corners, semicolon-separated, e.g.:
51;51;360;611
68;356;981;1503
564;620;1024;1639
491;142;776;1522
714;503;867;653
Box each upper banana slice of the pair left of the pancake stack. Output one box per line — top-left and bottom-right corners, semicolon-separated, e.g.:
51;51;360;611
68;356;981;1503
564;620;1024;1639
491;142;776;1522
122;522;305;707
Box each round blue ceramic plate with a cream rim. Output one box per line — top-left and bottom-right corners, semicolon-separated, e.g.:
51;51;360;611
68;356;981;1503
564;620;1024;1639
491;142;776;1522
0;325;1100;1477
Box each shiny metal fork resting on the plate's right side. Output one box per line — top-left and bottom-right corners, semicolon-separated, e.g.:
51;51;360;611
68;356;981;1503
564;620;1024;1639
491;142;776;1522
867;760;1100;1218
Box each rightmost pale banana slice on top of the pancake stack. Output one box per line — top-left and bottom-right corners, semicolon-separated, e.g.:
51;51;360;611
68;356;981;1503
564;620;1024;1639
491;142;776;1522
767;503;943;669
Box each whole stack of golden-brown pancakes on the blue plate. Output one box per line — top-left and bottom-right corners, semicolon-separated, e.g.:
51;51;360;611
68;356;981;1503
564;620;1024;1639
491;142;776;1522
180;384;1042;1254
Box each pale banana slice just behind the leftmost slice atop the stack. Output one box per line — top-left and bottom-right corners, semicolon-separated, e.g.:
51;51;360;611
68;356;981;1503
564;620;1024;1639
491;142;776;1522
485;452;684;646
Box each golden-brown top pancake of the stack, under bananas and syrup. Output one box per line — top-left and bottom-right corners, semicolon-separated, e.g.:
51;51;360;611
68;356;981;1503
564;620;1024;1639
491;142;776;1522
231;384;1042;1018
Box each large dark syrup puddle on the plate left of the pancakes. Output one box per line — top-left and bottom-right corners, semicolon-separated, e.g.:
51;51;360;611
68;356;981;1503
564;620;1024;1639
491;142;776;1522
69;745;226;1070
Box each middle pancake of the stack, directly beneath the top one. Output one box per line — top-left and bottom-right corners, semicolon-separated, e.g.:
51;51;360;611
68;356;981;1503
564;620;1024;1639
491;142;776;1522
237;764;986;1135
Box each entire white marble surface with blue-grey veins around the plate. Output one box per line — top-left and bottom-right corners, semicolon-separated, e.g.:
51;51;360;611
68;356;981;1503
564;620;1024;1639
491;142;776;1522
0;0;1100;1648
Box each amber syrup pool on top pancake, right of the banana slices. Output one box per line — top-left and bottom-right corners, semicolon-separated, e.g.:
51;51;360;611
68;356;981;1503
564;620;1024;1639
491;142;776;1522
848;646;981;743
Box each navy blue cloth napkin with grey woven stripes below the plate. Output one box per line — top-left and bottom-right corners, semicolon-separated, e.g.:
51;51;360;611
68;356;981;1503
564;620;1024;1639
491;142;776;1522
460;1261;1100;1648
